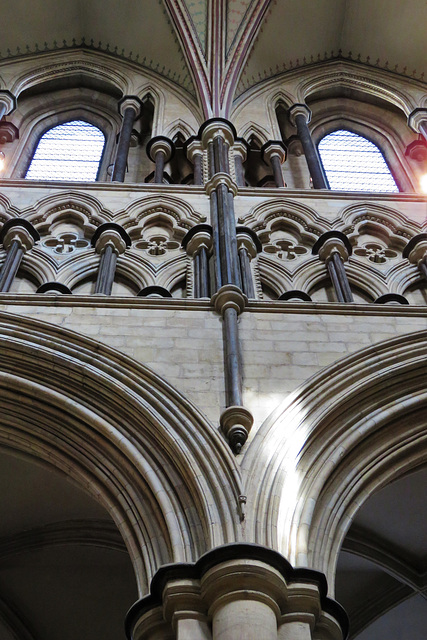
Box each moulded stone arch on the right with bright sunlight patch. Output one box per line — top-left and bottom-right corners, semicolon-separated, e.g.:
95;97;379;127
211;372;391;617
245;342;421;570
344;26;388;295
244;331;427;589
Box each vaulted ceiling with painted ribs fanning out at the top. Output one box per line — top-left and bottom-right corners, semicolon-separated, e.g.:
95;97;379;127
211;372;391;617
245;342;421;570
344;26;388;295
0;0;427;116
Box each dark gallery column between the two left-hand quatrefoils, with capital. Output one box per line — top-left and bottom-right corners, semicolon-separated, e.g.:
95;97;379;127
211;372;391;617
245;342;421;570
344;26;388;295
92;222;132;296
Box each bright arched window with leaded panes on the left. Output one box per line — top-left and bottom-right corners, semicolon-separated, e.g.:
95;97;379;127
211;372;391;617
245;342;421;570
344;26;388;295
25;120;105;182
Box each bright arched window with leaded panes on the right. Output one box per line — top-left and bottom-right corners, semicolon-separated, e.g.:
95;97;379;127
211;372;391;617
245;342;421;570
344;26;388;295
319;129;399;193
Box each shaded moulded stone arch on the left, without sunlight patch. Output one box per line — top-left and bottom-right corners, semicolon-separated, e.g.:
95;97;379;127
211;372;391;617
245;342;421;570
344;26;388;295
0;314;241;593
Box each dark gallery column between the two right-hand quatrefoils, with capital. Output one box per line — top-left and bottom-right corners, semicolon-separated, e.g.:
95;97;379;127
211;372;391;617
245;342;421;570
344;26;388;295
313;231;353;302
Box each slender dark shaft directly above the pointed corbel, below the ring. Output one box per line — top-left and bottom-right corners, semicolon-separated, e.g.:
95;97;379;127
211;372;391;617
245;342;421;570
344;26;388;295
223;308;242;407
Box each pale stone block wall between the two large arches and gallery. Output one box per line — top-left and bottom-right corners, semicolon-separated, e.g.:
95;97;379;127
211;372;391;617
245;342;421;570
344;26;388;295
0;296;427;438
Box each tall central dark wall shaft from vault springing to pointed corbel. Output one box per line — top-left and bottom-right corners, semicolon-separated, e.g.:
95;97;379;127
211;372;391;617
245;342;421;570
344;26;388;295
199;118;253;453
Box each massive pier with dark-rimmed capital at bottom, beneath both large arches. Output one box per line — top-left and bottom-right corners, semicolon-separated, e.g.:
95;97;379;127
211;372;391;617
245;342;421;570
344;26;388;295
126;544;348;640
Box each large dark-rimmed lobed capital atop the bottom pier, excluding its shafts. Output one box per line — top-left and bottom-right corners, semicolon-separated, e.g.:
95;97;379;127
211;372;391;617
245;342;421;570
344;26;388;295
126;543;348;640
